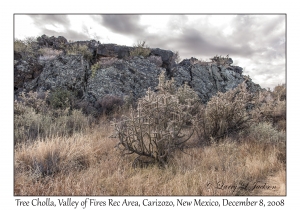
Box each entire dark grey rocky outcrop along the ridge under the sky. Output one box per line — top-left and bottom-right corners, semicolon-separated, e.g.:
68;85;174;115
14;36;260;107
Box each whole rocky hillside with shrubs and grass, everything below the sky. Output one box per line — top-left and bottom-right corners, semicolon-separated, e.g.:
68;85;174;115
14;35;286;196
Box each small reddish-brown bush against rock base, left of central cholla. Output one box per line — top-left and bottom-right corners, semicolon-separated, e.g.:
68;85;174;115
99;95;124;114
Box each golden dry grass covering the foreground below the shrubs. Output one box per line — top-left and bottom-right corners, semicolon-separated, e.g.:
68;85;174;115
14;122;286;196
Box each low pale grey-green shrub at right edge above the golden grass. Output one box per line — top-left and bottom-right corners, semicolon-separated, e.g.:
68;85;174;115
247;122;286;143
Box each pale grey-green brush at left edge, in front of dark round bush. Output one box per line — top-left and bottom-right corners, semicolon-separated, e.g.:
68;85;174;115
14;97;93;144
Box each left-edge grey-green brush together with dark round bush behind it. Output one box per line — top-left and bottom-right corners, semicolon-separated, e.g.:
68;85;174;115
14;88;93;145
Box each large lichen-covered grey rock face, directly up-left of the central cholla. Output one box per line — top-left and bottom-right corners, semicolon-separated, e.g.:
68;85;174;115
86;57;164;102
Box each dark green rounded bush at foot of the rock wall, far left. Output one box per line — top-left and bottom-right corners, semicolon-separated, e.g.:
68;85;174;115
48;88;75;109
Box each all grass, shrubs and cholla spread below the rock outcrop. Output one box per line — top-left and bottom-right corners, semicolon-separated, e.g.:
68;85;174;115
14;74;286;196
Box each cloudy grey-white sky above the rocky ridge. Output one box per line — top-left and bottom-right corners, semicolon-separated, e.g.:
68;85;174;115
14;14;286;89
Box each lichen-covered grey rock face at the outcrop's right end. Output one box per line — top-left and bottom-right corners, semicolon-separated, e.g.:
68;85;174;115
172;58;260;103
